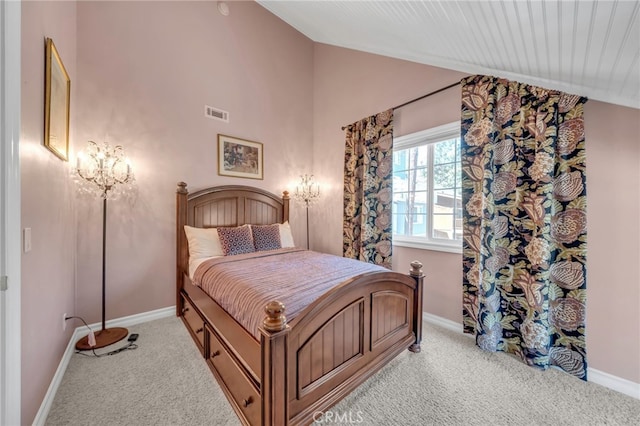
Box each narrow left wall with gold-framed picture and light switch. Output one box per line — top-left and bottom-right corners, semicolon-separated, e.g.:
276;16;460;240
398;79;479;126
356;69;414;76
20;2;77;424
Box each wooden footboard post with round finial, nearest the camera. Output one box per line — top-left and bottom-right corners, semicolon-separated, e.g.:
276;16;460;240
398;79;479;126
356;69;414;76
260;301;290;426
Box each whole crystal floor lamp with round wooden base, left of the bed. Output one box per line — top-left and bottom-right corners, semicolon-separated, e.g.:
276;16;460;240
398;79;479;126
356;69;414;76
76;141;133;351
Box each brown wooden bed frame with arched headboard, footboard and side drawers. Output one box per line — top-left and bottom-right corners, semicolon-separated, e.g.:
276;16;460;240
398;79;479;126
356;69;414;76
176;182;424;426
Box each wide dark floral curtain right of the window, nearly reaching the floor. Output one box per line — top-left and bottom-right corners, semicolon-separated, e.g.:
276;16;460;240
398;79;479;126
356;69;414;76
461;76;587;380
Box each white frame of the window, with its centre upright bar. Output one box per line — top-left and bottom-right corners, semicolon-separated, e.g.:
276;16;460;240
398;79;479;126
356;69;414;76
393;121;462;254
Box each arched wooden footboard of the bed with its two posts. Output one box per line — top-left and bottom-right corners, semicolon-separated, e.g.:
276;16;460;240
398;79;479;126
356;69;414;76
261;262;423;425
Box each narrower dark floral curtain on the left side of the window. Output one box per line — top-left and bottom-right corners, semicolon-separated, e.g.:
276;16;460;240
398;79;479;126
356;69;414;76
342;110;393;269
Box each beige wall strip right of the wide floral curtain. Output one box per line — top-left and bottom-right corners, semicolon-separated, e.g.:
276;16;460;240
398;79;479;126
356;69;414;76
584;101;640;383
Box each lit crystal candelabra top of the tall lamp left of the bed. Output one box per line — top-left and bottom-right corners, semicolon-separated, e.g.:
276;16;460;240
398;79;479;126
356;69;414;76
76;141;134;199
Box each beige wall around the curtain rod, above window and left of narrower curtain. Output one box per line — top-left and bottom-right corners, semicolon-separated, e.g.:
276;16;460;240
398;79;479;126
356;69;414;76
309;44;465;255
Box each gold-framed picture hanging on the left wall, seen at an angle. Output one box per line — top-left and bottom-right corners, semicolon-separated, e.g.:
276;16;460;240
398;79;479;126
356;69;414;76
44;38;71;161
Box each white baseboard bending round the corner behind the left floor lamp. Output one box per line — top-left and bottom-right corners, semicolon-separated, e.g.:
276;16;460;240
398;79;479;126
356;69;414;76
33;306;176;426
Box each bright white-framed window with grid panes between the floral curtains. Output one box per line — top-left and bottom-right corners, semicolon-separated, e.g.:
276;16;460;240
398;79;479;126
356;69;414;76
393;122;462;253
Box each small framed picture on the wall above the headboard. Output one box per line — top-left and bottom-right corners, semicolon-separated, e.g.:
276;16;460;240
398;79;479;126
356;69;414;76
218;134;263;179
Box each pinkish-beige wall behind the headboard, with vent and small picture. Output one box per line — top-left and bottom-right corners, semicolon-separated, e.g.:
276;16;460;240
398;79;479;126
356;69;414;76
72;2;313;332
